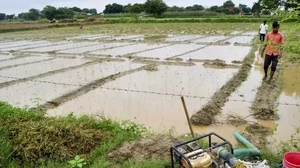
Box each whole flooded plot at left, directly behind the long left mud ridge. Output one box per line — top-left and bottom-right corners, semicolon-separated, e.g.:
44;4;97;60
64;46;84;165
0;62;142;107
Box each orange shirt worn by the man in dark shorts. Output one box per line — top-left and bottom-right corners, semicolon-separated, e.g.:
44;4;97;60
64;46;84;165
266;32;284;56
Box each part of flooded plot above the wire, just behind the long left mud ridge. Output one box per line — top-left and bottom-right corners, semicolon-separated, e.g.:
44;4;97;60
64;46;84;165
39;62;143;85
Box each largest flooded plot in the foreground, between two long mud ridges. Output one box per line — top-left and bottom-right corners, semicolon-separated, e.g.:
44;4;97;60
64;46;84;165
48;65;237;134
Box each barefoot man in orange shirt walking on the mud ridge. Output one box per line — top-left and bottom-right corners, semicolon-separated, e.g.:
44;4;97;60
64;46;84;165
261;21;284;82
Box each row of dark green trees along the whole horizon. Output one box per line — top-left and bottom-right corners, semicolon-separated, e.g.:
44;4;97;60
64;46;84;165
0;0;300;21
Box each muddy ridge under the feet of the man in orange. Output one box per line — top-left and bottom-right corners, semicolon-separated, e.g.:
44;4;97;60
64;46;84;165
251;66;283;120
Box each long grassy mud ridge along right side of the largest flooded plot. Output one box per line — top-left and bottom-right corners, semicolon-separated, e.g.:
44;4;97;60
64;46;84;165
191;45;258;125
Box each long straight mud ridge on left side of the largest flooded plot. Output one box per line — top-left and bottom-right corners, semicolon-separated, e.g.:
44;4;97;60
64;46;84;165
41;65;149;110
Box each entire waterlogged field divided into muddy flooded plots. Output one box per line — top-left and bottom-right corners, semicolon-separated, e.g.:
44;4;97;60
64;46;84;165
0;24;300;144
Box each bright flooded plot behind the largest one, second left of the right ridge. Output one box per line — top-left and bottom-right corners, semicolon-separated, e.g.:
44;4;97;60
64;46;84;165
134;44;204;59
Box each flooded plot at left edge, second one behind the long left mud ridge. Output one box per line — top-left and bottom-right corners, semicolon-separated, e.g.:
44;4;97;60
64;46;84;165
0;58;87;83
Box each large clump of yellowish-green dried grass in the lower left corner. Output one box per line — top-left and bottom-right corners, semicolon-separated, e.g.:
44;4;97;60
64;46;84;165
0;102;109;165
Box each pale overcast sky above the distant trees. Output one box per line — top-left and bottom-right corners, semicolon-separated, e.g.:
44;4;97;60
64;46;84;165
0;0;255;14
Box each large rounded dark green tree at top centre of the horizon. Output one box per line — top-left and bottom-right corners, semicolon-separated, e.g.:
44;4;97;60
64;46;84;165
145;0;168;17
